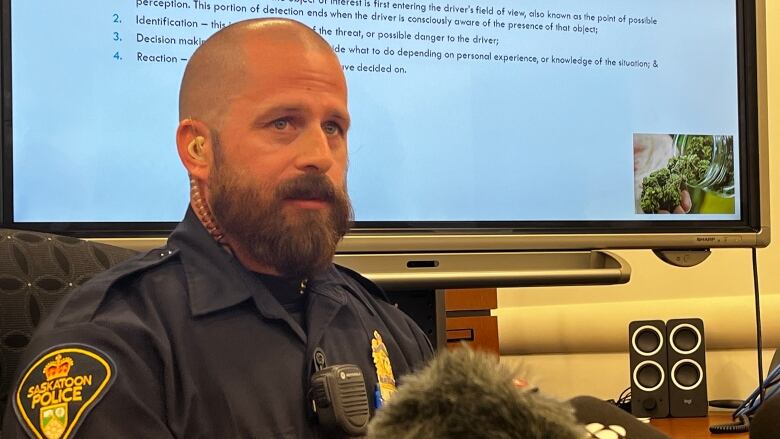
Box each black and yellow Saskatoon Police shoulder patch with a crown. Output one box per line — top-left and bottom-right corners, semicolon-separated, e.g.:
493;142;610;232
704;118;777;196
13;344;116;439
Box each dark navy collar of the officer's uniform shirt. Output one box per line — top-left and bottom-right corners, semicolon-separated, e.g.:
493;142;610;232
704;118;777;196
168;208;346;317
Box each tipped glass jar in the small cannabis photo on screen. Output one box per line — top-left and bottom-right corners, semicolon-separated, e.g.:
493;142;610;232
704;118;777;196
674;134;734;198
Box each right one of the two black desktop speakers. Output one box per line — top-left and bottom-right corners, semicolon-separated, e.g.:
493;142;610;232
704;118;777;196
666;319;708;418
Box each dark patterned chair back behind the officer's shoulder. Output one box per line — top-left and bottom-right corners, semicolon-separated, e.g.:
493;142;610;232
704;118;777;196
0;229;136;435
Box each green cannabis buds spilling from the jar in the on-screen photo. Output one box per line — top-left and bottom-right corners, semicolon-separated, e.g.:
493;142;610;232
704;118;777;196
639;136;713;213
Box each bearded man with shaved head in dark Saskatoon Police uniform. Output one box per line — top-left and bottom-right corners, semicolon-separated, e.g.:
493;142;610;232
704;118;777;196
3;19;431;439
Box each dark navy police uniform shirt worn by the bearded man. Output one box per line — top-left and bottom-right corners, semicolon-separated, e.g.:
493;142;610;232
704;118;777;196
3;210;432;439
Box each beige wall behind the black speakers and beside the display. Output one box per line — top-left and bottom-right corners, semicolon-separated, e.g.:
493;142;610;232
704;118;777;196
495;0;780;398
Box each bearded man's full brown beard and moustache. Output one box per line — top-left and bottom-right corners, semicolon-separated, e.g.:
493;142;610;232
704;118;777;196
208;154;352;279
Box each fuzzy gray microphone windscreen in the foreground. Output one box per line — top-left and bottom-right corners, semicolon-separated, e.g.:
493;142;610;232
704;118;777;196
367;348;585;439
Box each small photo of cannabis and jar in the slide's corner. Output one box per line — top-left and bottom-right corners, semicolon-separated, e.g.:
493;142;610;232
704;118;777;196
634;134;734;213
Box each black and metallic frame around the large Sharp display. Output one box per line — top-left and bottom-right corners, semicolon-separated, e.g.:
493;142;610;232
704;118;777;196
0;0;770;253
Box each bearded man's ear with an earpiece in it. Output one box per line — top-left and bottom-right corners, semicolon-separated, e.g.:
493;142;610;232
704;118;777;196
176;118;214;181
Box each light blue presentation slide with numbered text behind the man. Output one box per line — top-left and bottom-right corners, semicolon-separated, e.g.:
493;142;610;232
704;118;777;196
11;0;741;223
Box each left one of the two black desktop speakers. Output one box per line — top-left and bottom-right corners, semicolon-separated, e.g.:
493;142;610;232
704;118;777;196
628;320;669;418
